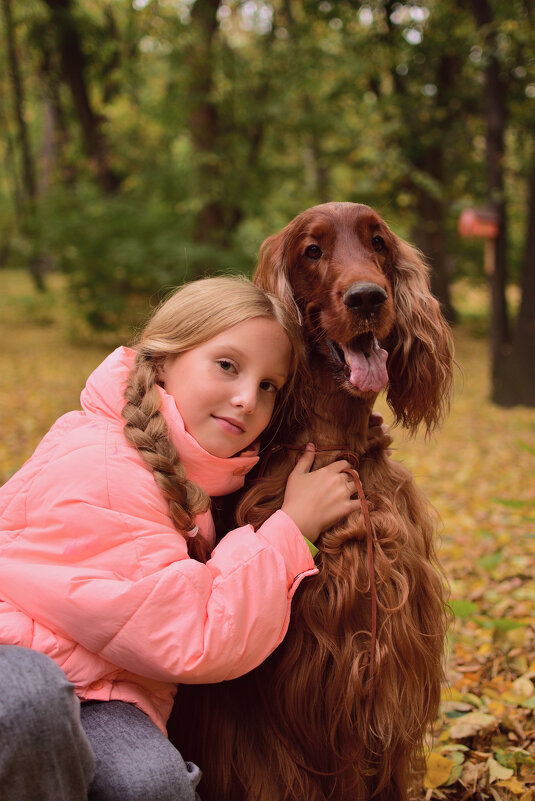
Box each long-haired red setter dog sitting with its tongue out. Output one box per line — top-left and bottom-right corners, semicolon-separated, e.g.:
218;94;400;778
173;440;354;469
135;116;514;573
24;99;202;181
170;203;452;801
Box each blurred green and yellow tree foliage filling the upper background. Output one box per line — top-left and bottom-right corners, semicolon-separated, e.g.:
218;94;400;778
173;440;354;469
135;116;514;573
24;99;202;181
0;0;535;327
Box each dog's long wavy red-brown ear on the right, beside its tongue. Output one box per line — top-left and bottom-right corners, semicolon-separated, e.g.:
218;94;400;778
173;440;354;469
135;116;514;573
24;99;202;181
387;237;454;433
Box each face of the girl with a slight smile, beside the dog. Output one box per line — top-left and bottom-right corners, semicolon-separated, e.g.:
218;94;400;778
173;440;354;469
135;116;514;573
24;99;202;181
161;317;291;458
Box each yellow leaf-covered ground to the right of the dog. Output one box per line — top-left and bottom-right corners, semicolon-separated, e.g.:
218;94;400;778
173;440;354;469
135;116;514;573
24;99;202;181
385;320;535;801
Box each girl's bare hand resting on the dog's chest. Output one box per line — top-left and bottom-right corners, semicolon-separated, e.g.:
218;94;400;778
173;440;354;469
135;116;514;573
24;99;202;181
281;442;360;542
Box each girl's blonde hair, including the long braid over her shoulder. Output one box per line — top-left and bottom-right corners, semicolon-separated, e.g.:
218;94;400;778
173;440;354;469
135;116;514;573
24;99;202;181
122;276;304;562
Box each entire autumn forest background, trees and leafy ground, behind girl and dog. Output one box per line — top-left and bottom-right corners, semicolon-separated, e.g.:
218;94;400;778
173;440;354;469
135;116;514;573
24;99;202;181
0;0;535;801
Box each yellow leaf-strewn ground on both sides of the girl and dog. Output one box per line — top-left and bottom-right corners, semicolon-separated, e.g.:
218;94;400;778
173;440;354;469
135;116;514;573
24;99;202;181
0;271;535;801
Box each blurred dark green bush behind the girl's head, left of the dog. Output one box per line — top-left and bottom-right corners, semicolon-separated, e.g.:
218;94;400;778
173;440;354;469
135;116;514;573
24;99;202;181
41;185;253;330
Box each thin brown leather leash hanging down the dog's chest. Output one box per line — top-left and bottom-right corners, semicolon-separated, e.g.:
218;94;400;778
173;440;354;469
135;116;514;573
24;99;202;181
257;444;377;777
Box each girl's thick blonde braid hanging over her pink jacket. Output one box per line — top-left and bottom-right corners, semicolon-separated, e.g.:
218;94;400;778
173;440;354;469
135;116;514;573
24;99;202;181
122;352;210;562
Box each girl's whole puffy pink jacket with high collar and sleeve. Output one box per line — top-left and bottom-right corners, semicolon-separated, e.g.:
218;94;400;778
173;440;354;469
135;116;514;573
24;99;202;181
0;348;317;731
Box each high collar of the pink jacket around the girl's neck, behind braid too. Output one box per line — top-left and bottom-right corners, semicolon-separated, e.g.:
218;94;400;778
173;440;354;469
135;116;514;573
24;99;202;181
80;347;258;496
